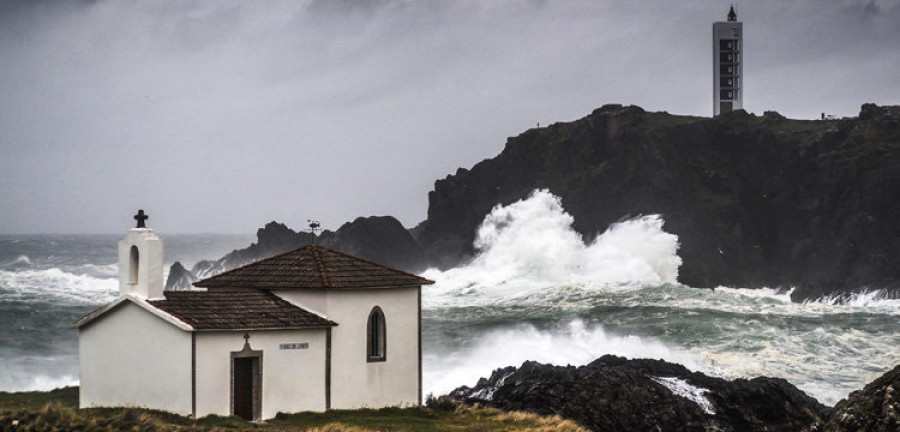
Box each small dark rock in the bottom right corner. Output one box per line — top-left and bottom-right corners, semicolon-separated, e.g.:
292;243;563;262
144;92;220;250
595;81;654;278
819;365;900;432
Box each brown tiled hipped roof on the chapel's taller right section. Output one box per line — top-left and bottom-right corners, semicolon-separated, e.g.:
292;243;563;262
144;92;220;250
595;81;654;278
194;245;434;289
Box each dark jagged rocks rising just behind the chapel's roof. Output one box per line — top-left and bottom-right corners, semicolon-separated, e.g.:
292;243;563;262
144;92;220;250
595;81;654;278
166;216;426;290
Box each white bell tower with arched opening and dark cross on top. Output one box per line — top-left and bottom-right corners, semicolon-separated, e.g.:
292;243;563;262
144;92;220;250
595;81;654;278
119;210;163;299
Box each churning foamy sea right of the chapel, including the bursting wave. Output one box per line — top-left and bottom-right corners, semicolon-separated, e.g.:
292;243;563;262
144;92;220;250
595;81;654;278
423;191;900;404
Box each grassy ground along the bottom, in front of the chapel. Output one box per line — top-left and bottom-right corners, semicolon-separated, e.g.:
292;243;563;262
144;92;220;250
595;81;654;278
0;387;584;432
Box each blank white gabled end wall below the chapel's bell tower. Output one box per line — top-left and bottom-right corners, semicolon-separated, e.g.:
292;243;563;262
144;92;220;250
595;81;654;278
78;301;191;415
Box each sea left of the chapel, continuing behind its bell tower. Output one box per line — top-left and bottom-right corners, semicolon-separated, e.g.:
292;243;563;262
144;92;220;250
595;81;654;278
0;235;253;391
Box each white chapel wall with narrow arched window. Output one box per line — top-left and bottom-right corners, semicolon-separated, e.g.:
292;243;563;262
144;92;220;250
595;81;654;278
276;287;420;409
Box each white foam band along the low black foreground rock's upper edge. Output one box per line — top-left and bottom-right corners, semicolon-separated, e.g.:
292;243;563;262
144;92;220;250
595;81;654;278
424;319;700;394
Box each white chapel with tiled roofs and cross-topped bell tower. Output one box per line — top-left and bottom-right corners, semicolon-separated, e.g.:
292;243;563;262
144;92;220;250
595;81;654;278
72;211;433;420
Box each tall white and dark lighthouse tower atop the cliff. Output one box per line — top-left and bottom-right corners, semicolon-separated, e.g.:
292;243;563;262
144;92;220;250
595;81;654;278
713;6;744;116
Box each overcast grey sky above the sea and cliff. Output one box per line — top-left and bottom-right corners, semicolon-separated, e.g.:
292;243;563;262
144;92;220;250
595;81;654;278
0;0;900;233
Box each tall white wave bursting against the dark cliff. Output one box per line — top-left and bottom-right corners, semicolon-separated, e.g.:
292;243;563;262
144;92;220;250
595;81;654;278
424;190;681;307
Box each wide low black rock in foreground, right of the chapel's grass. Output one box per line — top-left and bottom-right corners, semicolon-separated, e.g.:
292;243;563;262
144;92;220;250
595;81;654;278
450;356;830;432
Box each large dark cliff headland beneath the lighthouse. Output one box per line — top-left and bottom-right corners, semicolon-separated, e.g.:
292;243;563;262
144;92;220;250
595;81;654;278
413;104;900;299
